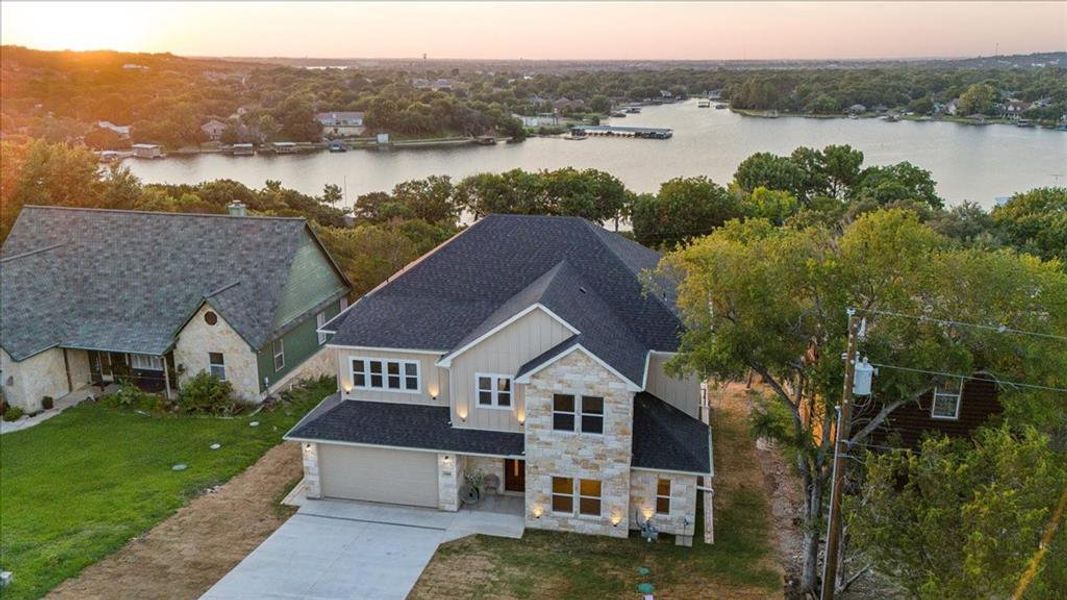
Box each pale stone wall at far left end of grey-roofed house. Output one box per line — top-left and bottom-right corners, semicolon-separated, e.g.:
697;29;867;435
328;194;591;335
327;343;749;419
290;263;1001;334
0;348;69;412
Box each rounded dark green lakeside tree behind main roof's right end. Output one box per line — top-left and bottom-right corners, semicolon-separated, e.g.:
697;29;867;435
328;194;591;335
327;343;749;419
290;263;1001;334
631;176;740;248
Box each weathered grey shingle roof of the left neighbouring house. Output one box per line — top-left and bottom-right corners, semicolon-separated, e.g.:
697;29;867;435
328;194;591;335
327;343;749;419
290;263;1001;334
0;206;341;360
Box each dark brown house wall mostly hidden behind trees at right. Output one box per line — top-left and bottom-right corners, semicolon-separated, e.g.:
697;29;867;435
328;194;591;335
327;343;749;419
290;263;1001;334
856;374;1003;448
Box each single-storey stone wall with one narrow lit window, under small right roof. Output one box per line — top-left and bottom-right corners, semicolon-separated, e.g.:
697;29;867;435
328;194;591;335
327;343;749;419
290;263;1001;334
630;470;697;546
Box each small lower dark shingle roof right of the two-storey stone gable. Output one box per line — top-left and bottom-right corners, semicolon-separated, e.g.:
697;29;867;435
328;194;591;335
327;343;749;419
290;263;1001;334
632;392;712;473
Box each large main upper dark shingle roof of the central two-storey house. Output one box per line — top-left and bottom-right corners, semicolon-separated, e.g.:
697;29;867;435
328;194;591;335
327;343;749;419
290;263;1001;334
331;215;682;383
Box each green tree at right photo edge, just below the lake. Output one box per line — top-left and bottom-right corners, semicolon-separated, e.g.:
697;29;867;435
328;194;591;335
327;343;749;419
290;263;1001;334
992;188;1067;262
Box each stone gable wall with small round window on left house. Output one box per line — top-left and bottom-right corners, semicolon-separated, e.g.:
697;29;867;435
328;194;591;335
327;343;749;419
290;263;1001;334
174;304;262;402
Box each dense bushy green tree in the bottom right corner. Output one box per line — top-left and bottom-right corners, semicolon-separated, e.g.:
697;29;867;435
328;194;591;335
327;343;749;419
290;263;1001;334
847;426;1067;599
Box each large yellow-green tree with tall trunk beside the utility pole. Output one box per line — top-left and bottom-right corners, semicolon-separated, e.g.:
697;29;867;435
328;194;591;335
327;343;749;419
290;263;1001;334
660;209;1067;590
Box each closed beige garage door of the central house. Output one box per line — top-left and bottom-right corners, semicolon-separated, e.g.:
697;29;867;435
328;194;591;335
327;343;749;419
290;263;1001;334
319;444;437;508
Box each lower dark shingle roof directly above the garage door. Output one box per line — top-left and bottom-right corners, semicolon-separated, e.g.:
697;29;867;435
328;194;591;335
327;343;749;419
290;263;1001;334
285;394;526;456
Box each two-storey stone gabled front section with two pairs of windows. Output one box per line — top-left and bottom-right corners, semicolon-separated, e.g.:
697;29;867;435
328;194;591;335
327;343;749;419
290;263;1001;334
526;350;634;537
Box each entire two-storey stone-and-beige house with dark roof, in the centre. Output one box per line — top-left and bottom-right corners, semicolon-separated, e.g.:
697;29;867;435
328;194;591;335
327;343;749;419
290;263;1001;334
286;215;713;544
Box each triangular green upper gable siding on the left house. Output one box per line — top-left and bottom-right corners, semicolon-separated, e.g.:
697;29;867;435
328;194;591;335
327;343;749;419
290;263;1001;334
273;231;346;330
